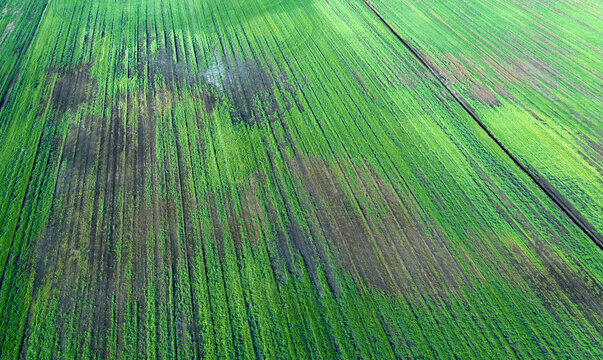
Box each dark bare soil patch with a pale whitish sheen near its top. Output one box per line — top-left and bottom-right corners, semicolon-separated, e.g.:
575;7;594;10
136;42;303;125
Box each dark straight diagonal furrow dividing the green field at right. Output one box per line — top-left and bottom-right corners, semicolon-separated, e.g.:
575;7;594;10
362;0;603;250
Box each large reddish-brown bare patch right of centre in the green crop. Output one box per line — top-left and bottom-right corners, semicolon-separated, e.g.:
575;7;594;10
276;157;470;298
